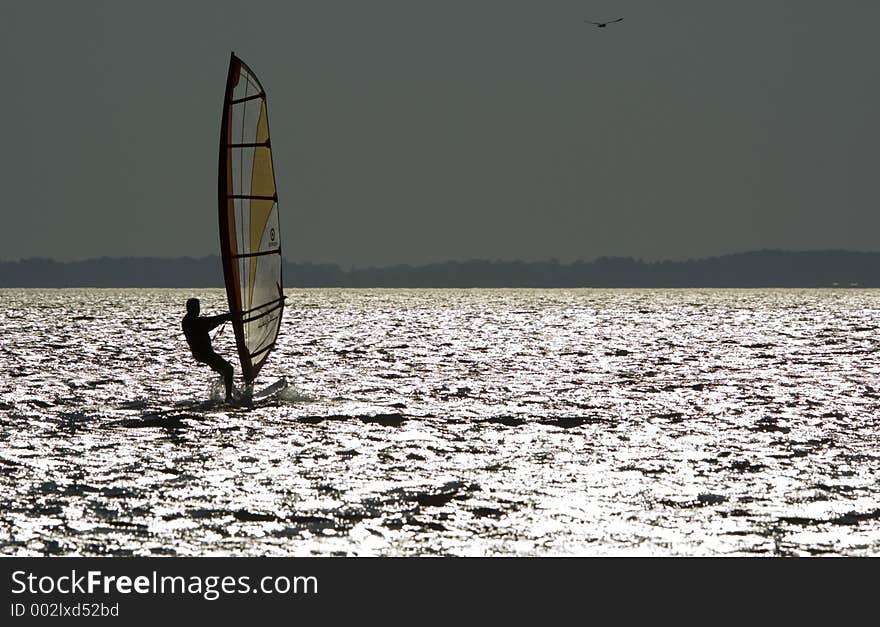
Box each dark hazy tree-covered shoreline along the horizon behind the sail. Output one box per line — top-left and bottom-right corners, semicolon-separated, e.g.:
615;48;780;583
0;250;880;288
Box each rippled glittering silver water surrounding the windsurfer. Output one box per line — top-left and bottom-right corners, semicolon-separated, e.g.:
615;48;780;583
0;289;880;556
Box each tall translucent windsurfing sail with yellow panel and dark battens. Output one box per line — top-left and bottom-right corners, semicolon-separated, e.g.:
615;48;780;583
218;54;284;384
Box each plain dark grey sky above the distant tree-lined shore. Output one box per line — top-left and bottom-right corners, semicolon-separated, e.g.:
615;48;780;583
0;0;880;267
